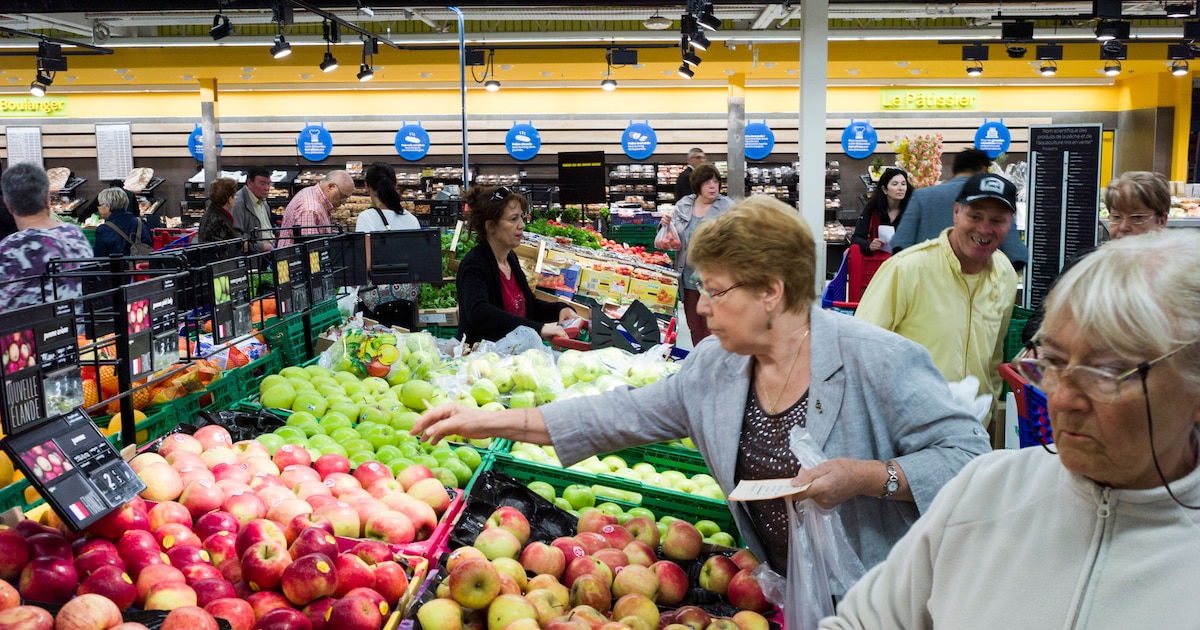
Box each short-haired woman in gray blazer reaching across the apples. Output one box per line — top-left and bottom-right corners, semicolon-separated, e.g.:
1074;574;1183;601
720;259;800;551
416;198;989;604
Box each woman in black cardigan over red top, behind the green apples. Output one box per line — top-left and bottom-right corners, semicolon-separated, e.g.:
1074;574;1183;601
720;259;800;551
456;186;576;343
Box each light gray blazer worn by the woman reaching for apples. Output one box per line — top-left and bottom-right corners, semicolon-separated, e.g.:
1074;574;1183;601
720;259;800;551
541;307;990;568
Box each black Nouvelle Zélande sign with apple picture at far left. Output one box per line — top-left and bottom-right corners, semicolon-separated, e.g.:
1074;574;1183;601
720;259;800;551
0;301;83;434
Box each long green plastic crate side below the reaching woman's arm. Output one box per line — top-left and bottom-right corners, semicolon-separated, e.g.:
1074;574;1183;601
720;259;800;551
480;454;738;538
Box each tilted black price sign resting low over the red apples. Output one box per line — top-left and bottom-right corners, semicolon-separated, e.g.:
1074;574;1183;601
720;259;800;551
0;407;146;532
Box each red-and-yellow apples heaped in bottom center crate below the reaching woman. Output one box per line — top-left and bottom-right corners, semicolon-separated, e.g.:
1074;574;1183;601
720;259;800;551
416;506;770;630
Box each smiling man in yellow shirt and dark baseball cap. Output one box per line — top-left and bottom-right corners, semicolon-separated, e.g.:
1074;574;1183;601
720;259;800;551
854;173;1016;412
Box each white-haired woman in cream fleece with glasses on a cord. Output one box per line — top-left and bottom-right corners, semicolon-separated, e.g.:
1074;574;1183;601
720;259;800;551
823;230;1200;629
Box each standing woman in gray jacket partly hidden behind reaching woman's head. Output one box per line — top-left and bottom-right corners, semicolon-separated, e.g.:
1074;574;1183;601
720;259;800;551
671;164;733;344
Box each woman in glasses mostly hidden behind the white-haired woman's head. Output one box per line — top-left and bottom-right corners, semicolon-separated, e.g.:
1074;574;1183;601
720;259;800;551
1021;170;1171;344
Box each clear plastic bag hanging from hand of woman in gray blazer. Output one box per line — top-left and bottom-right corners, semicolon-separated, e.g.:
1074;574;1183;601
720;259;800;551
784;427;866;630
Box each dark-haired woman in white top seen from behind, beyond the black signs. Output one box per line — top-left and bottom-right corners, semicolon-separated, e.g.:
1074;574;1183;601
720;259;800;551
354;162;421;328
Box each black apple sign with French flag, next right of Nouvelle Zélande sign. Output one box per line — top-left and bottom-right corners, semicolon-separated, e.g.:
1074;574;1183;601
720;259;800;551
116;277;179;382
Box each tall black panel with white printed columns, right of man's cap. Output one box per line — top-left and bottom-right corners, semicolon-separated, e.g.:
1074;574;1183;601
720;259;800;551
1025;125;1103;308
